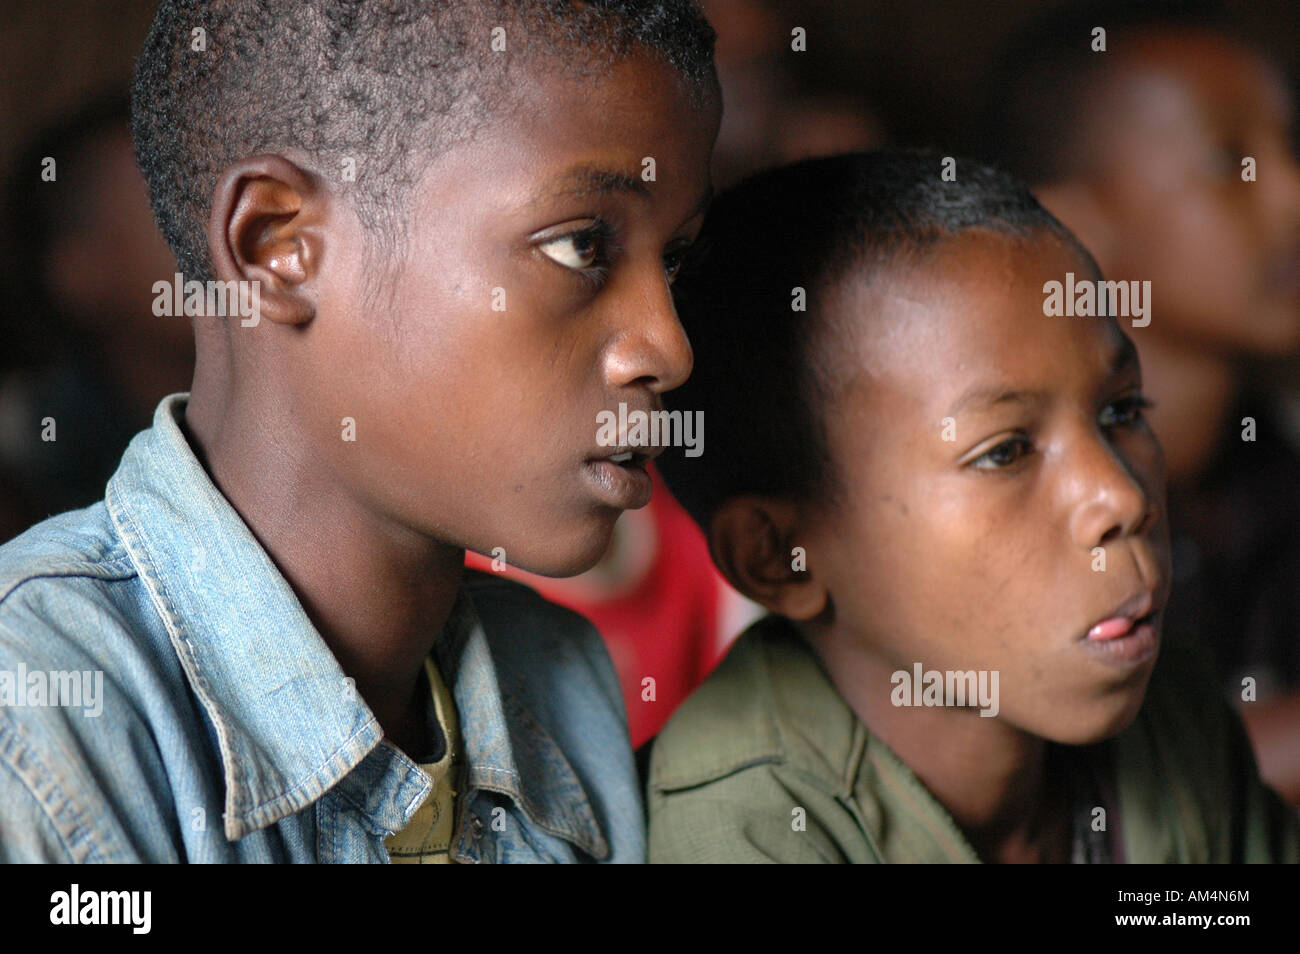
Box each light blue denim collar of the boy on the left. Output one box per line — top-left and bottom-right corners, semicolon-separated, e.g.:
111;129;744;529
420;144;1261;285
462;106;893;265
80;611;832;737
105;393;608;858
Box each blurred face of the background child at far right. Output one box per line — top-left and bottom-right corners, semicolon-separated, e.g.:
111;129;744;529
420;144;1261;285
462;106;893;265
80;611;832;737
1089;32;1300;354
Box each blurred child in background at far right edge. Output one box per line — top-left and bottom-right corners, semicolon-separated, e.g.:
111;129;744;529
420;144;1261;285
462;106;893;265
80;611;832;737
979;4;1300;805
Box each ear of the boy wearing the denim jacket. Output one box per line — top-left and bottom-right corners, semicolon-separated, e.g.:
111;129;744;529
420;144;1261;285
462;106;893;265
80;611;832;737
208;156;325;325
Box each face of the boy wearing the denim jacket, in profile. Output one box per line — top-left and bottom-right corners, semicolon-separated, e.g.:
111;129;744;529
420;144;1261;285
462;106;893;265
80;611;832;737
302;57;720;574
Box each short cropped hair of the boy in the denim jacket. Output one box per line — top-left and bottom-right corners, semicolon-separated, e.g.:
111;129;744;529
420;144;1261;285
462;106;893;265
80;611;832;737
131;0;715;279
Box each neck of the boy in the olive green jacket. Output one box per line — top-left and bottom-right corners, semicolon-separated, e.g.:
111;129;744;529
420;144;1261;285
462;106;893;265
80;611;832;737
806;633;1070;862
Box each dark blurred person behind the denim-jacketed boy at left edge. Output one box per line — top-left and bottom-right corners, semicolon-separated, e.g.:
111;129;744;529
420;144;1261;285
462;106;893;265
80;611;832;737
0;95;194;541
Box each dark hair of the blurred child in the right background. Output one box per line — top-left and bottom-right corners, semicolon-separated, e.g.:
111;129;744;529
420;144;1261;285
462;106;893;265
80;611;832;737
971;0;1234;186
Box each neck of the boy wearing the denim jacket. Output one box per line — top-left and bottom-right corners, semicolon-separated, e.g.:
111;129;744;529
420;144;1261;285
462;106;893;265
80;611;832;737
185;377;464;758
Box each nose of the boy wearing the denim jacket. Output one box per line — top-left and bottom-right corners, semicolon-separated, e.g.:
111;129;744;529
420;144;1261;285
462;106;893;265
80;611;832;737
606;270;694;394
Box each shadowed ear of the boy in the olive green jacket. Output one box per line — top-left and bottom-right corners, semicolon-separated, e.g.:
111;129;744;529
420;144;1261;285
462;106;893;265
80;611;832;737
709;496;827;620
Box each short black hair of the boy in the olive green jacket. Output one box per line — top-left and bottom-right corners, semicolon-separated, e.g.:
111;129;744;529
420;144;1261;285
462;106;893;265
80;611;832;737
658;151;1096;532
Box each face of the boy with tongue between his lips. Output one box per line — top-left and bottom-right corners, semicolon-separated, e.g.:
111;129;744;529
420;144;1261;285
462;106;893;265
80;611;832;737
807;233;1169;743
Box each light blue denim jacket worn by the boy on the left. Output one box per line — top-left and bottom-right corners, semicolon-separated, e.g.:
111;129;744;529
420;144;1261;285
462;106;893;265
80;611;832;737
0;394;645;863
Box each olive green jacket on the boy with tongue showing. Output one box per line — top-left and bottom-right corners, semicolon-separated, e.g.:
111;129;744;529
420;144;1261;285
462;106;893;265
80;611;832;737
647;616;1300;863
